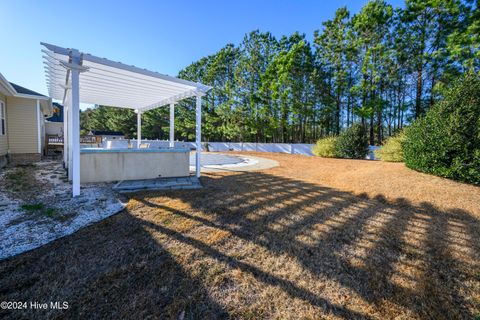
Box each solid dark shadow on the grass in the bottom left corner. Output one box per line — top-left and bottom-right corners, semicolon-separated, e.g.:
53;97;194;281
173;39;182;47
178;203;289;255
0;208;227;319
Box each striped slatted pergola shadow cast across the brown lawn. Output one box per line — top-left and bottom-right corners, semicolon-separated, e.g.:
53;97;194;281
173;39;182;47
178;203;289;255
134;172;480;319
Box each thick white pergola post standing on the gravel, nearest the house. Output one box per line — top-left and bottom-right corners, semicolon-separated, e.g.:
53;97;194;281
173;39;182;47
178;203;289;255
70;51;80;197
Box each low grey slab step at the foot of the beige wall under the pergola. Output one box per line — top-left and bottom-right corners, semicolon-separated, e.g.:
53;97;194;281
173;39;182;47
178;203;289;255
113;176;202;192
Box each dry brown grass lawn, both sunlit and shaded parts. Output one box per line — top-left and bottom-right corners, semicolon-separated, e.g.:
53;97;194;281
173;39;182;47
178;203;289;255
0;154;480;319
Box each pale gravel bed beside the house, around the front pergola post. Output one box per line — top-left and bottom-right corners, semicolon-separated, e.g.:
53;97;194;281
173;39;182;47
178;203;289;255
0;161;125;260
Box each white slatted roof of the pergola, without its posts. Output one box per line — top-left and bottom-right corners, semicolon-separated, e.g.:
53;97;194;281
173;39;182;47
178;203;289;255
42;43;210;111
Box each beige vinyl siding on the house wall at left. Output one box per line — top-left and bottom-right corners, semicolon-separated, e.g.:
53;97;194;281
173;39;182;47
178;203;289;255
7;97;38;153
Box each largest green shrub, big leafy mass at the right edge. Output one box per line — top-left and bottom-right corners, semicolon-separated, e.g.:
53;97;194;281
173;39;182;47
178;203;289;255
402;74;480;184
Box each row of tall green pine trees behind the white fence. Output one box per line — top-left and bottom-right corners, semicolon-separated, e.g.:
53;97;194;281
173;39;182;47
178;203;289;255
81;0;480;145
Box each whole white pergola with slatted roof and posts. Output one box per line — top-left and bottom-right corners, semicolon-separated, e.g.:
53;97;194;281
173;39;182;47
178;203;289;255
41;43;211;196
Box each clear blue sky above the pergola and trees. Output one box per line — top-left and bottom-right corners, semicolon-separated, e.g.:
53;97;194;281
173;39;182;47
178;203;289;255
0;0;403;99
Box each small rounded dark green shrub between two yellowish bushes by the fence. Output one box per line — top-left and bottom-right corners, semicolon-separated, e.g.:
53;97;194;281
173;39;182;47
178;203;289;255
335;123;368;159
